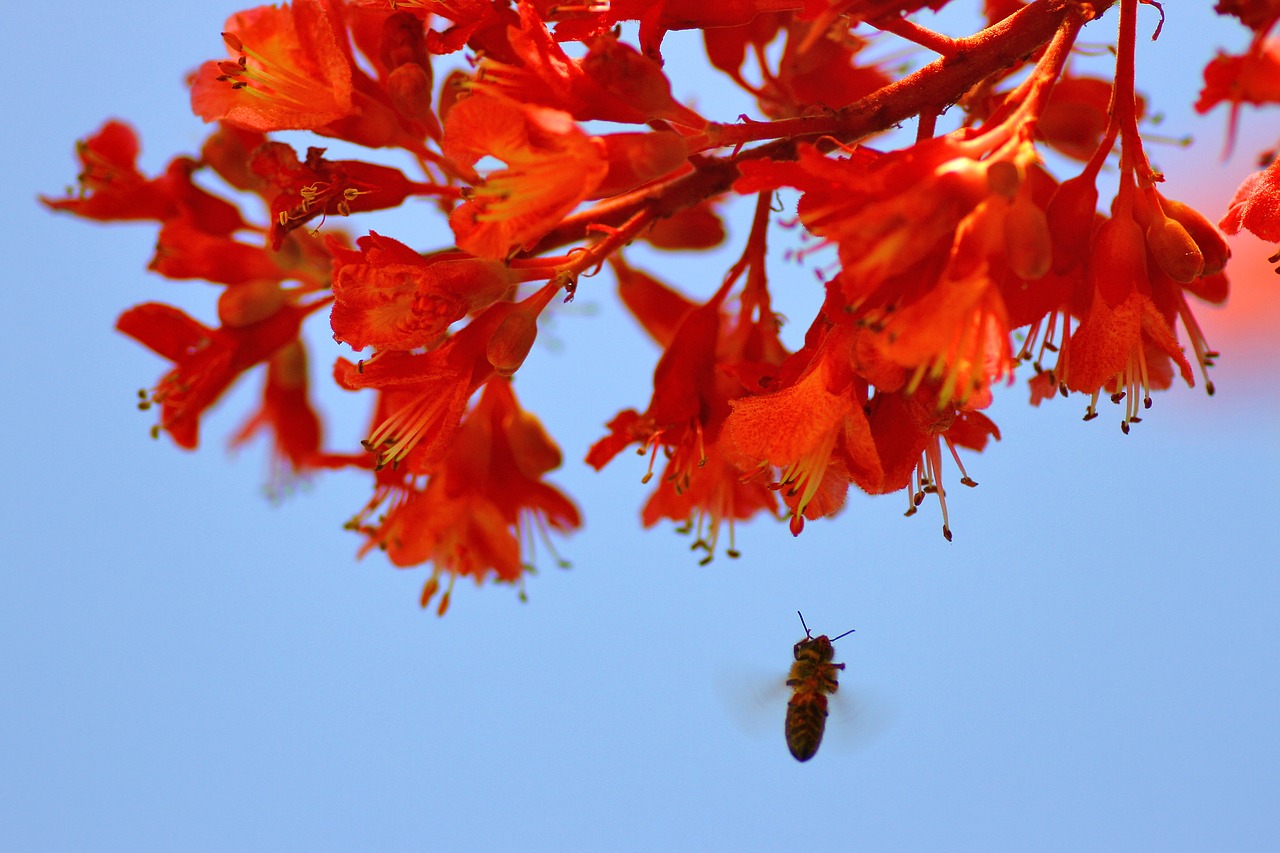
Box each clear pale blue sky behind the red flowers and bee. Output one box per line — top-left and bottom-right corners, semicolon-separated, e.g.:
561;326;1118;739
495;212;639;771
0;0;1280;850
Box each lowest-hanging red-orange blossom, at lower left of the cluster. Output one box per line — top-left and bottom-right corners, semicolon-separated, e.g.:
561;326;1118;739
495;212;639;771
348;378;581;615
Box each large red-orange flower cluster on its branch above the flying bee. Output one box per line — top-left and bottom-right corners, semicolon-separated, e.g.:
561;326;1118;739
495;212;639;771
44;0;1280;613
